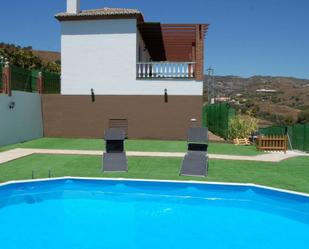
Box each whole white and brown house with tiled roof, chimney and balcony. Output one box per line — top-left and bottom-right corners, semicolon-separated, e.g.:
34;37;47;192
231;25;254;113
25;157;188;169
42;0;208;139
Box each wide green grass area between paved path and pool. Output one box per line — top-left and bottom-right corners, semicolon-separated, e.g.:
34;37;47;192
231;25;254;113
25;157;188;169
0;155;309;193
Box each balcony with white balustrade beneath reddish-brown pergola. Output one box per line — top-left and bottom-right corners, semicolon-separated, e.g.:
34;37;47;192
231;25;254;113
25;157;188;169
136;22;208;81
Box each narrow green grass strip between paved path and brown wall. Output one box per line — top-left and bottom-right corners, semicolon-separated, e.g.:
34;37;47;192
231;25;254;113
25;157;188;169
0;138;263;156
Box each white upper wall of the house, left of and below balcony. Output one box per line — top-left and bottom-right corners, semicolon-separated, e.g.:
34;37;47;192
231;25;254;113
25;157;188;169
61;19;203;95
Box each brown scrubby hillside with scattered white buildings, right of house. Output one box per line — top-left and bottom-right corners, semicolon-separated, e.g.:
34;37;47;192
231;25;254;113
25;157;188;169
204;76;309;124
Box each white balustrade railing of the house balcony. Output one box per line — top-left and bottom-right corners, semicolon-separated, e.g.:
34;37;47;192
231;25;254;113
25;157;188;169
137;62;195;79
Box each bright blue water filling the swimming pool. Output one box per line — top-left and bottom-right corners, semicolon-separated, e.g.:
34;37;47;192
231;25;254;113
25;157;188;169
0;179;309;249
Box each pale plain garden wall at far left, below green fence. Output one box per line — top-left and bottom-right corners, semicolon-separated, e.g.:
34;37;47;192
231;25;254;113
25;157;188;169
0;91;43;146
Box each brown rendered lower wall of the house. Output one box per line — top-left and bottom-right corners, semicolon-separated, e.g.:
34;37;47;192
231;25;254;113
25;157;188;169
42;94;203;139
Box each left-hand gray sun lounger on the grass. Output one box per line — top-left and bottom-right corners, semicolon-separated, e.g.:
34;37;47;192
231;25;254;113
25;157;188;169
102;128;128;172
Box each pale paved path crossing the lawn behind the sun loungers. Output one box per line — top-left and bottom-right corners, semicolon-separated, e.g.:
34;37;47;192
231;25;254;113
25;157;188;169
0;148;309;164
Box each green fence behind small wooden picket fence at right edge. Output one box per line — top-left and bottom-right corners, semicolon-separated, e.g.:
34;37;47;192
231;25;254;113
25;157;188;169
259;124;309;152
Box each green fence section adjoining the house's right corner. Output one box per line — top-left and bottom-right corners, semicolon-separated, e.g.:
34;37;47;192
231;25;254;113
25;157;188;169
203;103;236;139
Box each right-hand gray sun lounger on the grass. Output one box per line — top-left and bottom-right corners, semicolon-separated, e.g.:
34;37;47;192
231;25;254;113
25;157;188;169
180;128;208;176
